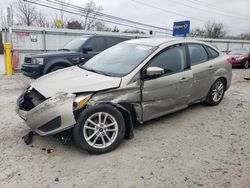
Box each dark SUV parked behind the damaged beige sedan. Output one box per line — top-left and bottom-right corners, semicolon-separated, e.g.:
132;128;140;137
21;35;131;78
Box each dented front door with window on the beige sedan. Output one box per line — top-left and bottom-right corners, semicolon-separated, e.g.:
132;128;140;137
142;44;193;121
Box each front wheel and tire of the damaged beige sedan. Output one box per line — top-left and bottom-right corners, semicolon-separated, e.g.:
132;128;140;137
73;104;125;154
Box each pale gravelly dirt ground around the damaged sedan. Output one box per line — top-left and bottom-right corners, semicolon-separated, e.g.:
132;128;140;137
0;69;250;188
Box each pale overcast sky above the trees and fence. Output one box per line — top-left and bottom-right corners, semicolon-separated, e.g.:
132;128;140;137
0;0;250;35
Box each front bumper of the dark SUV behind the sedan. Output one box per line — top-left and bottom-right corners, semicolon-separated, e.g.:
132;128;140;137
21;63;43;78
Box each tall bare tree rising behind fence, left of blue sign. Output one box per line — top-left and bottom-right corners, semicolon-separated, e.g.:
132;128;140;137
82;0;103;30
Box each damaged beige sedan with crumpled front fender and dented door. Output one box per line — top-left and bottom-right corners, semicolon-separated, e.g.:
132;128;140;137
16;38;232;154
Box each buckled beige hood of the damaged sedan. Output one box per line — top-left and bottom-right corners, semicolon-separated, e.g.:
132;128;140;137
31;66;121;98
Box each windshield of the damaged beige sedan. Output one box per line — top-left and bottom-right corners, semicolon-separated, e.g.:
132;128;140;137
80;44;156;77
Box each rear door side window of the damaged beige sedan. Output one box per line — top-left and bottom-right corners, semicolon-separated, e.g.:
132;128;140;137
188;44;208;65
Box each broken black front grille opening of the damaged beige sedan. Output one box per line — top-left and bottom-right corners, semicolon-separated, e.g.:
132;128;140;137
17;89;46;111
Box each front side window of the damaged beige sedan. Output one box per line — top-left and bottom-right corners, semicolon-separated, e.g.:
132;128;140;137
149;46;188;73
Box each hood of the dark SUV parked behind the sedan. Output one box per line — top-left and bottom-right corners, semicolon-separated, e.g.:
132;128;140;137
26;51;81;58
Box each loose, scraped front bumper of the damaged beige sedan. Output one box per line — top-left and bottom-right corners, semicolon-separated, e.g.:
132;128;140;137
16;93;76;136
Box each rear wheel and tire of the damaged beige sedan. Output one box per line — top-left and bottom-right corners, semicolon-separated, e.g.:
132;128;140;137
206;78;226;106
